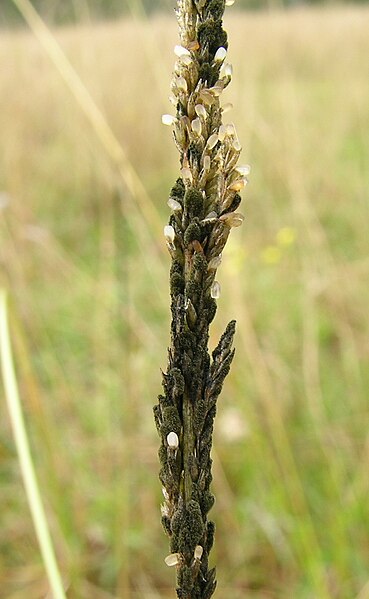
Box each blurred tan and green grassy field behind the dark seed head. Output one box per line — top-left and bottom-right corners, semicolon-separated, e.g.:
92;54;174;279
0;7;369;599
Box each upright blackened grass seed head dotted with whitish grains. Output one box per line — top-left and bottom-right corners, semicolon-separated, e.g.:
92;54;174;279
154;0;249;599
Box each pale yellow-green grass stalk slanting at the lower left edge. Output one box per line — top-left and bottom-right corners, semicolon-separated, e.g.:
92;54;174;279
0;290;66;599
